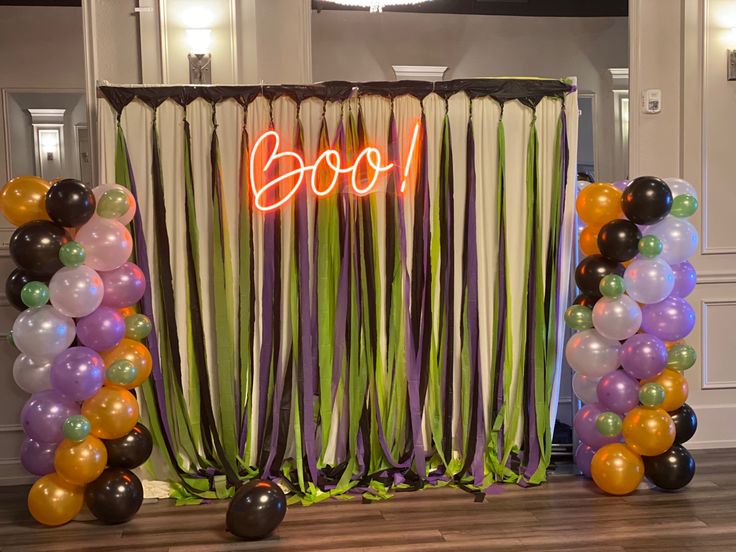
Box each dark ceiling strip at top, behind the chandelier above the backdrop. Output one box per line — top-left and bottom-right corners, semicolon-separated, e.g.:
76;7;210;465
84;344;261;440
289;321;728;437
312;0;629;17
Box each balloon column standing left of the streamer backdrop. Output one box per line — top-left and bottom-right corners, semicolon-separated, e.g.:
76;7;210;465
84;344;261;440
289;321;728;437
0;177;152;526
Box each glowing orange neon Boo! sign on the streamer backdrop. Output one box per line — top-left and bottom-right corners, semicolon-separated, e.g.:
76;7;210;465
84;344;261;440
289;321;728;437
249;122;421;212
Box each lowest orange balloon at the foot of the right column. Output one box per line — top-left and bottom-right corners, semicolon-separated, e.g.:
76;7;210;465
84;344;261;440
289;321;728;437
590;443;644;495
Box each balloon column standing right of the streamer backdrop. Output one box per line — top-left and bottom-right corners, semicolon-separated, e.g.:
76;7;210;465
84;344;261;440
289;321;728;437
565;176;698;495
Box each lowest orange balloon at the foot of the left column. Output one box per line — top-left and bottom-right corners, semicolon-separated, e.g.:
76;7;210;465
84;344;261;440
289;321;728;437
28;473;84;527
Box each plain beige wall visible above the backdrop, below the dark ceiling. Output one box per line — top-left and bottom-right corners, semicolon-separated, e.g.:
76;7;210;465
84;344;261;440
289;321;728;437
312;10;628;180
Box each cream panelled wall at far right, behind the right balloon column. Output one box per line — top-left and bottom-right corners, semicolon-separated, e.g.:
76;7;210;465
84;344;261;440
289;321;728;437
629;0;736;447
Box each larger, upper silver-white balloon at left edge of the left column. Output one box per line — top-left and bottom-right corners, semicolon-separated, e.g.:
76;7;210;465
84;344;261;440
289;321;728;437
13;305;76;358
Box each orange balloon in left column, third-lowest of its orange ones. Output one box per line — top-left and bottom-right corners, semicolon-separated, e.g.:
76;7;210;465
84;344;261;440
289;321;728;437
82;385;140;439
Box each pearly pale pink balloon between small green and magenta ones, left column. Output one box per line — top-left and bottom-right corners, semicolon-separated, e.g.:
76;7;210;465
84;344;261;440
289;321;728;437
49;265;105;318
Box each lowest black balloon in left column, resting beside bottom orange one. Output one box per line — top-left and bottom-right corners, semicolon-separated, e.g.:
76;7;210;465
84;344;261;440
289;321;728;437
84;468;143;523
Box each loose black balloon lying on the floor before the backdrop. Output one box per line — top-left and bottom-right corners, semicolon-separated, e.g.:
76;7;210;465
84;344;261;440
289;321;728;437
226;479;286;540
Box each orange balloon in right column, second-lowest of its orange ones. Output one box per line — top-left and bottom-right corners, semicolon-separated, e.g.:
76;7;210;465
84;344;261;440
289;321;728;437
622;406;675;456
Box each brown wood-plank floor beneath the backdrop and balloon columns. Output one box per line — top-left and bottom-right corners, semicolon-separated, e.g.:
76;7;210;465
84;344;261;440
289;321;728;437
0;449;736;552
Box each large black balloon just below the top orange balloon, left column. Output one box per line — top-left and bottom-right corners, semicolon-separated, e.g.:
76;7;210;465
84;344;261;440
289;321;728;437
9;220;71;278
